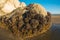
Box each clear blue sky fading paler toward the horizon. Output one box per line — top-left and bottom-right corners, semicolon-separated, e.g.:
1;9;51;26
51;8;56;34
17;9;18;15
20;0;60;14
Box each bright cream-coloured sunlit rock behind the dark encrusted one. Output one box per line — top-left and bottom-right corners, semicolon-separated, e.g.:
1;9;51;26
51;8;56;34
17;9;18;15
0;0;26;16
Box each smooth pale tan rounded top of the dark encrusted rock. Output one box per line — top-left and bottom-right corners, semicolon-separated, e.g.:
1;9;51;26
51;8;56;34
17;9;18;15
28;4;47;17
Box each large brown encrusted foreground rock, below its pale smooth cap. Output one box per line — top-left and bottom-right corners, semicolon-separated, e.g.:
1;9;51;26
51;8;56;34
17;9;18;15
0;4;51;40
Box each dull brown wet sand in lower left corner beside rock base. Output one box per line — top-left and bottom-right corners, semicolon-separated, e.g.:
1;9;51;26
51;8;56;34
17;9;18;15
0;28;14;40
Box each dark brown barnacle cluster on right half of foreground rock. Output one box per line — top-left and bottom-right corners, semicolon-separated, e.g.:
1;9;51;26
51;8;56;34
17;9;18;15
20;11;51;35
